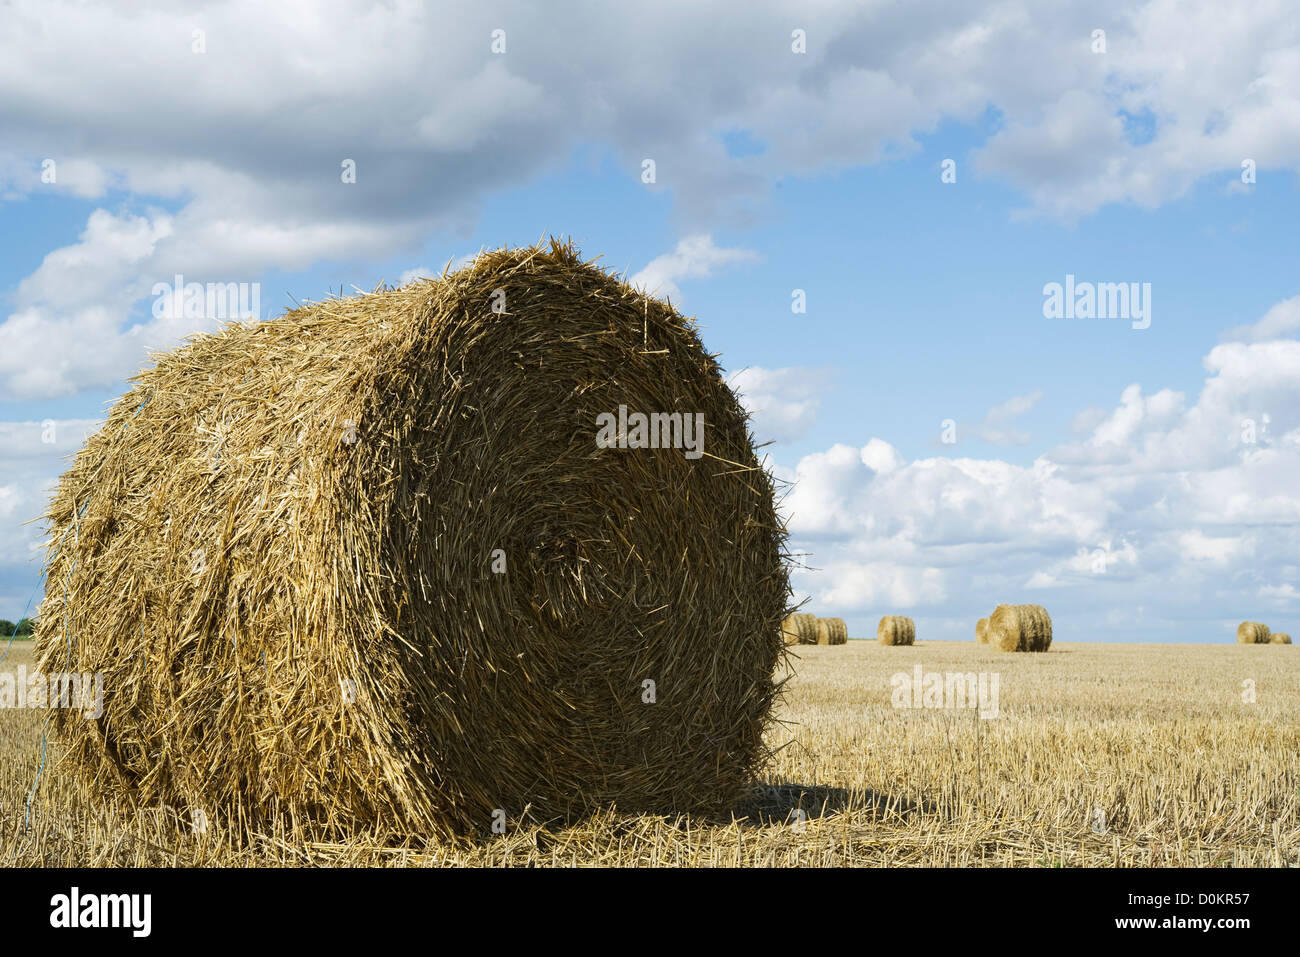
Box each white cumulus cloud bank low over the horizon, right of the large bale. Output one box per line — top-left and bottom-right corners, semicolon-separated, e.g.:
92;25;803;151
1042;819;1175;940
774;300;1300;640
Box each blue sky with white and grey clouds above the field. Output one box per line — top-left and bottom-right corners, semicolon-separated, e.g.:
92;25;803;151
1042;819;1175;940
0;0;1300;641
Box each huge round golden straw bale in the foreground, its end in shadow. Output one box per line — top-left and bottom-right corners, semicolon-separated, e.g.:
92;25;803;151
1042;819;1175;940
36;241;788;836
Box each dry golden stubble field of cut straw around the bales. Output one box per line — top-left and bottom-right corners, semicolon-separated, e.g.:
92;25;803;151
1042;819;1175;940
0;641;1300;866
